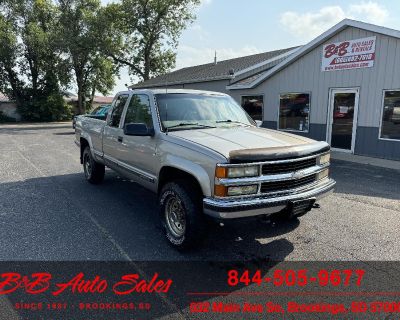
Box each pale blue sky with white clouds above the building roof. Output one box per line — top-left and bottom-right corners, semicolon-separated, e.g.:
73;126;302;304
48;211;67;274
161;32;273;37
103;0;400;92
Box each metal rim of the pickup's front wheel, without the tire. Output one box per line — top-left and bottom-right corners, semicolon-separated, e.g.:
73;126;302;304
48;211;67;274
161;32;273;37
165;195;186;238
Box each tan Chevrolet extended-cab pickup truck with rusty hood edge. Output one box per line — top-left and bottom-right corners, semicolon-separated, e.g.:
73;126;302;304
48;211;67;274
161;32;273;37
75;89;335;249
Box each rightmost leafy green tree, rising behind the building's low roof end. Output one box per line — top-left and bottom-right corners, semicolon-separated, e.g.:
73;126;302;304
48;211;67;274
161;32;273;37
103;0;200;80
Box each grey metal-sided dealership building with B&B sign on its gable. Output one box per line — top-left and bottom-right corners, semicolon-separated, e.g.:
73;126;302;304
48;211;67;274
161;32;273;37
131;19;400;160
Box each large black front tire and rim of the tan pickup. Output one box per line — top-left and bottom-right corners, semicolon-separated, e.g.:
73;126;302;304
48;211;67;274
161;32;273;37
159;181;206;250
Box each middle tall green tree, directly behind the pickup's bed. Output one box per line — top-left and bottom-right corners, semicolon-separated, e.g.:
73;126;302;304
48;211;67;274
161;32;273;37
59;0;118;113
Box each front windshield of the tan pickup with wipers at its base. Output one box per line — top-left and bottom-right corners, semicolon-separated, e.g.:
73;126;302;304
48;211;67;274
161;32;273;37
156;93;255;130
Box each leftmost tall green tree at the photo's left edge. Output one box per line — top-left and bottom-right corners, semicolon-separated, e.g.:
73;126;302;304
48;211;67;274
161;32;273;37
0;0;69;120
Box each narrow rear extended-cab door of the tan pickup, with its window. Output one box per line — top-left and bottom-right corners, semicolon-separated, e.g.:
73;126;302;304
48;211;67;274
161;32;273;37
103;93;129;170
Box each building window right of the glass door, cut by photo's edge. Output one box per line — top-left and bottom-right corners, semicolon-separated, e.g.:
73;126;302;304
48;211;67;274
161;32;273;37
381;90;400;140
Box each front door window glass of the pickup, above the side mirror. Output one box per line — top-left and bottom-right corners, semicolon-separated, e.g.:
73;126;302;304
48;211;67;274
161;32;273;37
124;94;153;128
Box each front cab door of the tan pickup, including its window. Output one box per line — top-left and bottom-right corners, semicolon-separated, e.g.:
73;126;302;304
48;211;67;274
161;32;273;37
118;94;157;189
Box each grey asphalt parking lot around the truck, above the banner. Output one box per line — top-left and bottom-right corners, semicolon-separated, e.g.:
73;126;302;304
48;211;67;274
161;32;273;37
0;124;400;260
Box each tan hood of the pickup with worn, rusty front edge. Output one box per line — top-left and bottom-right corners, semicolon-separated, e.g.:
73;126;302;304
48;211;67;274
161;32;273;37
169;126;316;159
